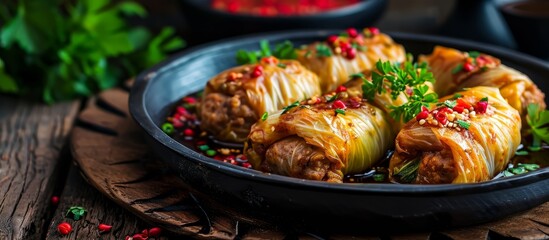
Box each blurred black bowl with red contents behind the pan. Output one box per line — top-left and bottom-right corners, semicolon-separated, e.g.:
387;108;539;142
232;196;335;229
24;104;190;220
179;0;387;43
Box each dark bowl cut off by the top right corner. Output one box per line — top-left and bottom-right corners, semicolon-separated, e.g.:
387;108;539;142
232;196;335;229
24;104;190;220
499;0;549;60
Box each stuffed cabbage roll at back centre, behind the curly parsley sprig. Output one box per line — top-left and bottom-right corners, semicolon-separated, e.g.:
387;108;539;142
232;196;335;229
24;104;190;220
297;28;406;92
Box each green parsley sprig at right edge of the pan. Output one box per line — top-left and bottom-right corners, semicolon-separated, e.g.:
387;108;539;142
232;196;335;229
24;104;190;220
526;103;549;151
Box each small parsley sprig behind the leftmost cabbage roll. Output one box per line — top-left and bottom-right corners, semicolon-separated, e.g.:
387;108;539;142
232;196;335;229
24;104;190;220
236;40;297;64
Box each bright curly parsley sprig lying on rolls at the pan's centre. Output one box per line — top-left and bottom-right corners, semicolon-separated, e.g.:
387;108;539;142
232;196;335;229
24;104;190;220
360;60;438;122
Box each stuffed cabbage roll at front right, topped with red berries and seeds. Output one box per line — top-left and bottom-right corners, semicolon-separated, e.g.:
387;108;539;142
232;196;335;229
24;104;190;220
389;87;521;184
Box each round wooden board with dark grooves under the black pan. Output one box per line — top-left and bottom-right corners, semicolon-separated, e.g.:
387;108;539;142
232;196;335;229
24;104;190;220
71;89;549;239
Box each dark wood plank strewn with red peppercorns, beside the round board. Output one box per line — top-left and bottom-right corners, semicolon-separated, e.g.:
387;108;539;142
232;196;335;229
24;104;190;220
46;166;173;239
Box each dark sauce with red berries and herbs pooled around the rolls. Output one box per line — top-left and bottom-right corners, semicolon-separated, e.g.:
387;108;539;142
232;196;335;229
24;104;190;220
162;92;549;183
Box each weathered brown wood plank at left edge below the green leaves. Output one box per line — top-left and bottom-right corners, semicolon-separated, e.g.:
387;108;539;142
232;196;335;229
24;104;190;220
0;96;80;239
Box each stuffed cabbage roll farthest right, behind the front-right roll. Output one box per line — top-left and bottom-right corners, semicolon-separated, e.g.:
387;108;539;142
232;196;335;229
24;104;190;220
420;46;545;117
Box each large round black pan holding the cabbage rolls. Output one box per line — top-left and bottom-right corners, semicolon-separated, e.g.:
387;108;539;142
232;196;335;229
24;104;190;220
129;31;549;234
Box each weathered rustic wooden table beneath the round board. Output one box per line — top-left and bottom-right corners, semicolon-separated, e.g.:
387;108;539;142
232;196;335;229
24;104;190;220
0;91;549;239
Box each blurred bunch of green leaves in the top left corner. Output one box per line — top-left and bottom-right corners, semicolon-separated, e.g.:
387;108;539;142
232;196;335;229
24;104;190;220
0;0;185;103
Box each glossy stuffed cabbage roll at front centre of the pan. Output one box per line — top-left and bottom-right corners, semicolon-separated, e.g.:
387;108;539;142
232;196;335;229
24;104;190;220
244;89;395;182
